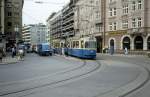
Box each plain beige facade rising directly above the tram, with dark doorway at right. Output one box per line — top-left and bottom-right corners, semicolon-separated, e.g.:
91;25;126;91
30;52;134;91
74;0;104;52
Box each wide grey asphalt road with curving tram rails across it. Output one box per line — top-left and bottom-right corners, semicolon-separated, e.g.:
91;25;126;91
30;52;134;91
0;54;149;97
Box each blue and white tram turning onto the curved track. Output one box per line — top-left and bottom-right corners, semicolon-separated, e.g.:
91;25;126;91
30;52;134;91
67;37;96;59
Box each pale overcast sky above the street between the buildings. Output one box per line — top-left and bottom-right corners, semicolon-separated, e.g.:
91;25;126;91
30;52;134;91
23;0;70;25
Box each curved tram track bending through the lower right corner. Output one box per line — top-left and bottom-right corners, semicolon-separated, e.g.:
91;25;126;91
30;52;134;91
93;59;150;97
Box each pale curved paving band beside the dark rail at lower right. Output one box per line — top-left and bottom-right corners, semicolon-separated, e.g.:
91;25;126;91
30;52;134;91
95;61;150;97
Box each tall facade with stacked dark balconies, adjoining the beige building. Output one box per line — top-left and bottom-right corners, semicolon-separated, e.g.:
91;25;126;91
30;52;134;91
61;0;79;47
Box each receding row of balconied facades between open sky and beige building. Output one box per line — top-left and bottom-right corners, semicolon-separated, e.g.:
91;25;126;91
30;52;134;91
47;0;78;47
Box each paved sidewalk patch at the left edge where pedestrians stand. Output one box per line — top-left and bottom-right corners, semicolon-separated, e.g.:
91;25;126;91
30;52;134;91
0;56;19;65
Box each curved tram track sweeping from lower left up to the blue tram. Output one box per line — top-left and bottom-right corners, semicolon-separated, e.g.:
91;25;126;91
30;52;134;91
0;60;101;97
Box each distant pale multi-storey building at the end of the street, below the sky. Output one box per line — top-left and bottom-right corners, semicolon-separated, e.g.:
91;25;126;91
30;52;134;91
22;24;48;46
